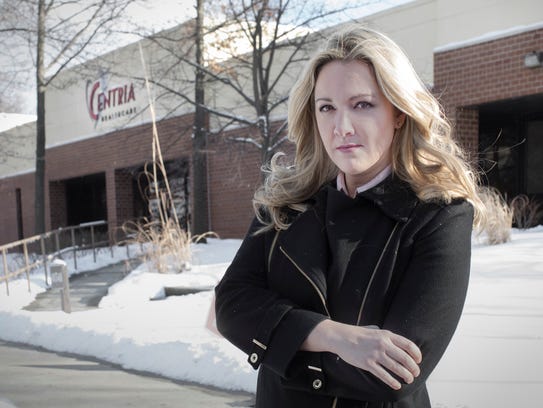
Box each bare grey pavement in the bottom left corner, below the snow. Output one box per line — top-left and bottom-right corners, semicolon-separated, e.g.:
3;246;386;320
0;341;254;408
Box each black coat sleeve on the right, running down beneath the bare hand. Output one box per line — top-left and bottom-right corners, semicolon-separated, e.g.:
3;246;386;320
289;202;473;401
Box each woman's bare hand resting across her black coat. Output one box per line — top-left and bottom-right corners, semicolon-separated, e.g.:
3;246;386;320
302;320;422;390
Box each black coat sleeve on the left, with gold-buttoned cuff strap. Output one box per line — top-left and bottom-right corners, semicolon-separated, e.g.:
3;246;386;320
215;219;326;376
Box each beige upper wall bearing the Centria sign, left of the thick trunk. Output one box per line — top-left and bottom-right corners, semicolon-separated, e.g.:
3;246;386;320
45;21;198;148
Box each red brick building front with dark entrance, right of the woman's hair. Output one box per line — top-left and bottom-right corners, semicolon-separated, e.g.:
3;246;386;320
435;24;543;199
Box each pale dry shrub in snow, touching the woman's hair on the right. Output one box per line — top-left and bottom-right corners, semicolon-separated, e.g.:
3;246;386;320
477;187;513;245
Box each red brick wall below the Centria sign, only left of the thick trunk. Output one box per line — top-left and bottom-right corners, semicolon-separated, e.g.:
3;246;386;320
0;115;196;244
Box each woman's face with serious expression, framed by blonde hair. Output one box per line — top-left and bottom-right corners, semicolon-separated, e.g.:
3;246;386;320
315;61;405;194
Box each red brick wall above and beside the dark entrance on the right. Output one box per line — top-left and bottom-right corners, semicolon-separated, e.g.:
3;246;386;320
434;29;543;153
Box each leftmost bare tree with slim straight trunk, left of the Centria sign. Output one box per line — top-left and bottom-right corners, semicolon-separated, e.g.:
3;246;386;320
0;0;138;233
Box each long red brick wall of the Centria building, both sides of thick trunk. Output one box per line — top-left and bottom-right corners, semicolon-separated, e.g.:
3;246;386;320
0;115;292;243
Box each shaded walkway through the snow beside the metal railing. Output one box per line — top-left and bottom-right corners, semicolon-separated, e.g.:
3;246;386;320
24;260;139;312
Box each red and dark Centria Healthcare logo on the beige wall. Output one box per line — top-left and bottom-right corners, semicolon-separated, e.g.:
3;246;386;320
86;75;136;126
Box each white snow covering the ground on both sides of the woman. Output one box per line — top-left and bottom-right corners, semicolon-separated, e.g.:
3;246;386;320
0;227;543;408
